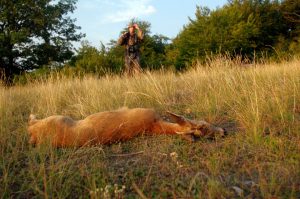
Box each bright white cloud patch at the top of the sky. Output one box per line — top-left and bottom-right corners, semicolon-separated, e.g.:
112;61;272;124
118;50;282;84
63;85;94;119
103;0;156;23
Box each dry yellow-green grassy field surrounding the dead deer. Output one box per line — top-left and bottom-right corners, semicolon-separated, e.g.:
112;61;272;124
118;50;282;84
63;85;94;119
0;60;300;198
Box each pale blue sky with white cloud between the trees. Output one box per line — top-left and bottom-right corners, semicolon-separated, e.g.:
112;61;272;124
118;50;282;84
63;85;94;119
72;0;227;47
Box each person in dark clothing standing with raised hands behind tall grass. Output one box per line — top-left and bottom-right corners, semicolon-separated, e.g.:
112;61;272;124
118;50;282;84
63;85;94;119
118;24;144;76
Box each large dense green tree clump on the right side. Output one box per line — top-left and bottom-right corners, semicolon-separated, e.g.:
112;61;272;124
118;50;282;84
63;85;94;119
168;0;299;69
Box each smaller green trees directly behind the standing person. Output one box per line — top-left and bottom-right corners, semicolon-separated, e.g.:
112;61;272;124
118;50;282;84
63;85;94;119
71;19;169;74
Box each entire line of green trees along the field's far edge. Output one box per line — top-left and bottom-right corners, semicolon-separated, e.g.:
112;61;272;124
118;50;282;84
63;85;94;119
7;0;300;81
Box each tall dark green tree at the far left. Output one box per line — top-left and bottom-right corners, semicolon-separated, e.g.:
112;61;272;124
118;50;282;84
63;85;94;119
0;0;83;83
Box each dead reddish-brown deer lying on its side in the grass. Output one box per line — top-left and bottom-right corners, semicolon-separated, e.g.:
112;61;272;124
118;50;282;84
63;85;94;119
28;108;225;147
